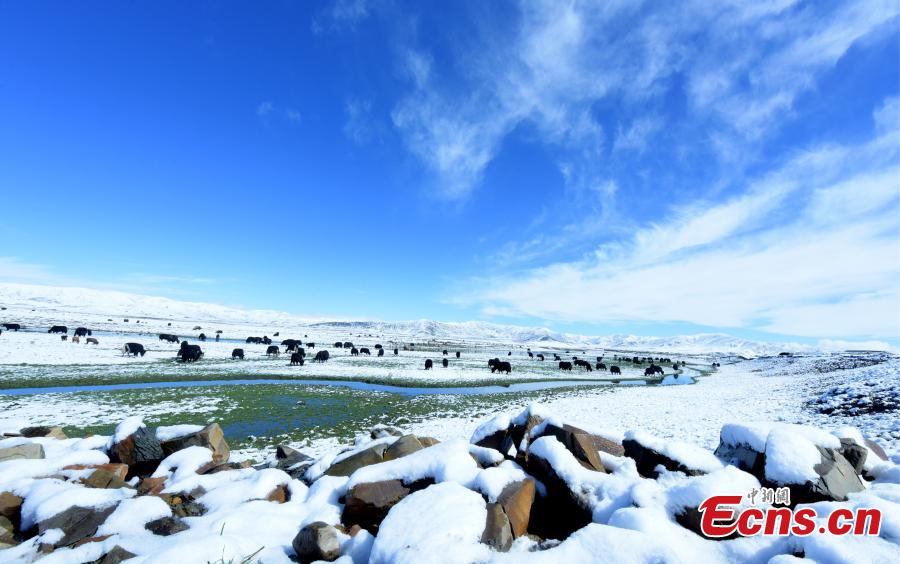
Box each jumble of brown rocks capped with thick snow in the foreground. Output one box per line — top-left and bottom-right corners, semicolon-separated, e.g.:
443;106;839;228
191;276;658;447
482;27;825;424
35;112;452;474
0;406;900;564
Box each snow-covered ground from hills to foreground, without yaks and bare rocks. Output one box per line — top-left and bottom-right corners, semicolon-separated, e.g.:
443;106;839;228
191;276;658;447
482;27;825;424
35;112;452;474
0;284;900;562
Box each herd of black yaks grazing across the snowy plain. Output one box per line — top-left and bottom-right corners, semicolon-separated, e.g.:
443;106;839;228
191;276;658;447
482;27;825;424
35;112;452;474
2;323;684;376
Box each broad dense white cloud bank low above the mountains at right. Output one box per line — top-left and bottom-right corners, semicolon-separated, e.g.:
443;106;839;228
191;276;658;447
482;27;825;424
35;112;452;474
459;132;900;339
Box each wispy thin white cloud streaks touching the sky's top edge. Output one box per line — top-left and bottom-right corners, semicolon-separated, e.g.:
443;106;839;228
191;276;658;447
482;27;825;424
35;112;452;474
392;0;898;198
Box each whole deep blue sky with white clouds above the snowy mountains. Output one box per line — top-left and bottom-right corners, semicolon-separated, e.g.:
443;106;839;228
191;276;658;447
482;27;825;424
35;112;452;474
0;0;900;345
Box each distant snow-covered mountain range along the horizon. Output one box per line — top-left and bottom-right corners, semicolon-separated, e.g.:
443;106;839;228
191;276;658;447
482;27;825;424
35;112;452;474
0;283;844;357
